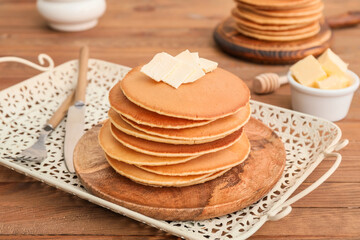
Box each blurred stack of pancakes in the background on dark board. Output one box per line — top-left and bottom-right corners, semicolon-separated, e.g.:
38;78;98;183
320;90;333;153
232;0;324;41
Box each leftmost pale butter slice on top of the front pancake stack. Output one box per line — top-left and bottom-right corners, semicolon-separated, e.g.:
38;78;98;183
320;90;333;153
140;52;179;82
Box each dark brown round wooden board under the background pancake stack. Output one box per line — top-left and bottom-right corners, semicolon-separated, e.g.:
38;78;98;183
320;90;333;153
214;17;331;64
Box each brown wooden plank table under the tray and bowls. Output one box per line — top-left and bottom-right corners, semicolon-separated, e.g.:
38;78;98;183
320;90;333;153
0;0;360;240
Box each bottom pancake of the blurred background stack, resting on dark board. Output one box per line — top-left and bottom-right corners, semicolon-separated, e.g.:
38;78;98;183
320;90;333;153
236;23;320;41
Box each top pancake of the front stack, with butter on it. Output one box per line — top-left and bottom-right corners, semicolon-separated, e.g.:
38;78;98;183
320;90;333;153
121;66;250;120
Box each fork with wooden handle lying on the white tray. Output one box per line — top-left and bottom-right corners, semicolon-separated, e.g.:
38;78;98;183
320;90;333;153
16;91;75;163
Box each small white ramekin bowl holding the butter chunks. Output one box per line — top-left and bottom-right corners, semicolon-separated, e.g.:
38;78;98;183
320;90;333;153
287;70;359;121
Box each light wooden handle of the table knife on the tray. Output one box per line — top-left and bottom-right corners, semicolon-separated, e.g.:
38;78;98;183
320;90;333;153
75;46;89;103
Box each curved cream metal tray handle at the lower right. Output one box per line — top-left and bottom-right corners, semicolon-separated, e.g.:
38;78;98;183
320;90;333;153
267;139;349;221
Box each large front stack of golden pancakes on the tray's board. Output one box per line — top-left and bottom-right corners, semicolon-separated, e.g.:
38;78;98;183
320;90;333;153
99;67;250;187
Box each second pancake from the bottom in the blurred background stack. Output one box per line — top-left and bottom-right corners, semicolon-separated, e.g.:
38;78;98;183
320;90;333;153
237;22;320;36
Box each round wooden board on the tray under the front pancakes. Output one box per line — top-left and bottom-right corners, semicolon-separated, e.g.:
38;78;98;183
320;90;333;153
74;119;286;221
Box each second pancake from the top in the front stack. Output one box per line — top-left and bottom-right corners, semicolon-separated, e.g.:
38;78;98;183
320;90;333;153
109;82;210;129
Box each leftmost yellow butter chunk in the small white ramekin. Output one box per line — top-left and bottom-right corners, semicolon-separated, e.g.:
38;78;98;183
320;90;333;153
290;55;327;87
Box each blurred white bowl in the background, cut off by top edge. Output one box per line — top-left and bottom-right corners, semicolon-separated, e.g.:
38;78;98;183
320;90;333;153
37;0;106;32
